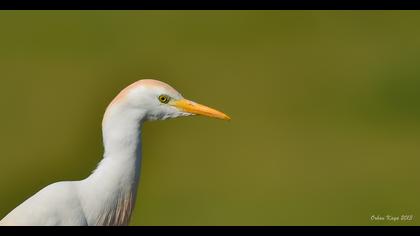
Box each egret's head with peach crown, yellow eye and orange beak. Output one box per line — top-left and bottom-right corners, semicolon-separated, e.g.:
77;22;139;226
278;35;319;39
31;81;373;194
105;79;230;120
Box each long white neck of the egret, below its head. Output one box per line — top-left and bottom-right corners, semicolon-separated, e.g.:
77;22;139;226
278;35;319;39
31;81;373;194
79;105;144;225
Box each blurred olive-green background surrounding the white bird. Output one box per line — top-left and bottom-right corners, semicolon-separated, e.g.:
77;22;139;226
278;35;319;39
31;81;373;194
0;11;420;225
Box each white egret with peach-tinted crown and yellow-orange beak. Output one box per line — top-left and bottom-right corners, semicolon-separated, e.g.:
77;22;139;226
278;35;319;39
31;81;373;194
0;80;230;225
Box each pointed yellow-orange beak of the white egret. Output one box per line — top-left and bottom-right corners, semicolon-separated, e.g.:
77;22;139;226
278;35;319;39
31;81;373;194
173;99;230;120
